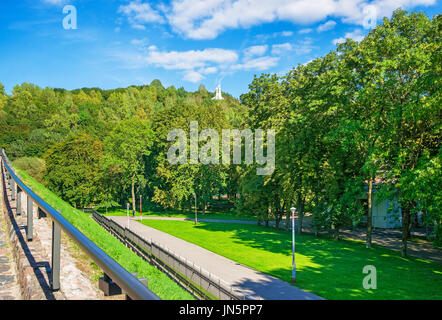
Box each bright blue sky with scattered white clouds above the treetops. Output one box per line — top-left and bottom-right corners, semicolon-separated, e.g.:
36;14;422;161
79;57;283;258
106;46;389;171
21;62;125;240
0;0;441;97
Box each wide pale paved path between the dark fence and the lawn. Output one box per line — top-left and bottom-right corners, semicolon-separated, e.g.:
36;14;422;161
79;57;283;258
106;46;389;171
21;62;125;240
109;216;322;300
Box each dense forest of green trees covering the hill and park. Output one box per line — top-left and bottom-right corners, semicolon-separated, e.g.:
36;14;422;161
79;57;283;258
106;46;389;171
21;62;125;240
0;10;442;256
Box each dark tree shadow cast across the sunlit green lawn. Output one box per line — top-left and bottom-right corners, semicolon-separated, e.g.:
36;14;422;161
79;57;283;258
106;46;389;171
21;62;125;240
189;223;442;299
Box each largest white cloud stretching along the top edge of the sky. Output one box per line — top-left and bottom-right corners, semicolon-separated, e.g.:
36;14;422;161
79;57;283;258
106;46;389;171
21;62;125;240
164;0;436;39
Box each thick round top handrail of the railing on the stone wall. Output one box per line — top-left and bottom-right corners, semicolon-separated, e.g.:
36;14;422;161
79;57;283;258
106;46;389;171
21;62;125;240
1;149;160;300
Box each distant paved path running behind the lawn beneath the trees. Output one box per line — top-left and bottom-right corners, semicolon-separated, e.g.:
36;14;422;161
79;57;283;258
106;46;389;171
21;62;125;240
133;217;442;264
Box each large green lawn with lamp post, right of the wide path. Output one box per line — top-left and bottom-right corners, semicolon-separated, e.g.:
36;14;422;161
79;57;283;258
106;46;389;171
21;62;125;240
143;220;442;299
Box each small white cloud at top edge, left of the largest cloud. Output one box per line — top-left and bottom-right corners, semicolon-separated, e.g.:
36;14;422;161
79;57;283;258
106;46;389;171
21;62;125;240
118;0;165;30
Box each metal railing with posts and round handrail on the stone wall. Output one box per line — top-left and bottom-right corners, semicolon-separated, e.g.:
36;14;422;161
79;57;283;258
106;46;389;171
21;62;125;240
1;149;159;300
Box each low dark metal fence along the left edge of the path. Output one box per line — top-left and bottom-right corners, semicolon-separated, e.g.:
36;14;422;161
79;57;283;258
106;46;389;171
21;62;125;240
89;210;249;300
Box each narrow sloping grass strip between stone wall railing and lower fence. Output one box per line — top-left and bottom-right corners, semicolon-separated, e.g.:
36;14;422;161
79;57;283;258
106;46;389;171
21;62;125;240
17;170;194;300
